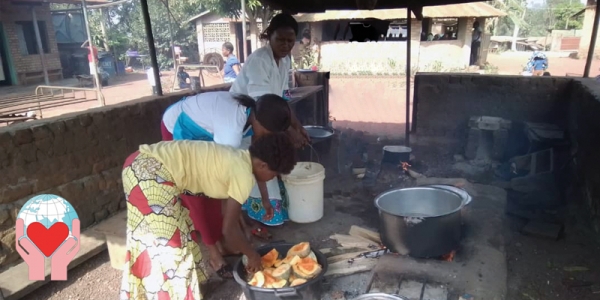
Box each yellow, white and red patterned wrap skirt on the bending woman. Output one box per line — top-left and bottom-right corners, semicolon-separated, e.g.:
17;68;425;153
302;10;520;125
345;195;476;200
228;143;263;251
120;152;206;300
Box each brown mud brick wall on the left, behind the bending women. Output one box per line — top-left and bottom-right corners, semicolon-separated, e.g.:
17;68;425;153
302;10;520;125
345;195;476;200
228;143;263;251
0;85;230;270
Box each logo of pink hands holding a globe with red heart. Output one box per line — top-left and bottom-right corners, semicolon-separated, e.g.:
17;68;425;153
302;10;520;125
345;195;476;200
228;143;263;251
15;194;80;280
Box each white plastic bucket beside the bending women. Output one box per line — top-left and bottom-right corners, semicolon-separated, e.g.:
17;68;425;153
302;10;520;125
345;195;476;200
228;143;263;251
282;162;325;223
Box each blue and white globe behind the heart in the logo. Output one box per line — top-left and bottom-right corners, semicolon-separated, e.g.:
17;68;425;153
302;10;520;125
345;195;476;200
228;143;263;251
17;194;79;239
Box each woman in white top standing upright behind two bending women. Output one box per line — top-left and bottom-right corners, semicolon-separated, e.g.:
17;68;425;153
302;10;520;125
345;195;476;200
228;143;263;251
229;14;309;230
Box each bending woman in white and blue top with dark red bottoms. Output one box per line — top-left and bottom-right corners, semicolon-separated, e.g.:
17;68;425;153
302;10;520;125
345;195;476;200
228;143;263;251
161;92;293;278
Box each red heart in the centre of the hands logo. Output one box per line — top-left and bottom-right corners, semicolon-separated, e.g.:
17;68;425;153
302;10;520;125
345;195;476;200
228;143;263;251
27;222;69;257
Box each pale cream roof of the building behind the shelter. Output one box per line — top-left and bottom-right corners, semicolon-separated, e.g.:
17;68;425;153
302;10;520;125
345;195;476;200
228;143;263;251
294;2;506;22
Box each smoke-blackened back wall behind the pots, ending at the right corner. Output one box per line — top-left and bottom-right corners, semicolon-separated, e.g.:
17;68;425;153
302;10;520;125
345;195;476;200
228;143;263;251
412;73;573;145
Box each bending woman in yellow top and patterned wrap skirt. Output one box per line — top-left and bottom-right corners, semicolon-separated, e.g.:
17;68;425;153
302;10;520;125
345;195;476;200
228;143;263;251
120;134;295;300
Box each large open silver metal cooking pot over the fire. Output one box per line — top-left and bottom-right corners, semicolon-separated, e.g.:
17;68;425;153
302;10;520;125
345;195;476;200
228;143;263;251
375;186;466;258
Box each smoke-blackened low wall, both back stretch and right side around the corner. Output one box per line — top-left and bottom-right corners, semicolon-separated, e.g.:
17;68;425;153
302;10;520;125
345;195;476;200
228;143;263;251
413;74;600;233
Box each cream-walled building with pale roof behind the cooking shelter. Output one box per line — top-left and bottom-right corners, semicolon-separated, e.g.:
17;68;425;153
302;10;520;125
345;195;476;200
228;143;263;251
295;2;505;73
